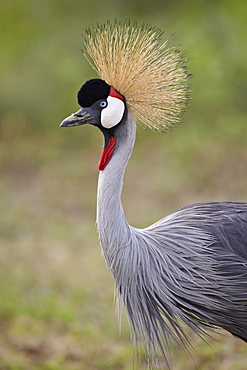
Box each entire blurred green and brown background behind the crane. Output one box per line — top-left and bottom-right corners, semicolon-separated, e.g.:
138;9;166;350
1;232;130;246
0;0;247;370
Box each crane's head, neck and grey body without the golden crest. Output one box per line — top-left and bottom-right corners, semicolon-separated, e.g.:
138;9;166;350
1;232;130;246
61;20;247;368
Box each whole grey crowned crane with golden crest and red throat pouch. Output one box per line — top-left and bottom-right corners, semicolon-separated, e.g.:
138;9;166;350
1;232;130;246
60;20;247;368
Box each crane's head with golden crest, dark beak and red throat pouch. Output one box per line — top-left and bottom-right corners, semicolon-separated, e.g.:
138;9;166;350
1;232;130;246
60;20;189;169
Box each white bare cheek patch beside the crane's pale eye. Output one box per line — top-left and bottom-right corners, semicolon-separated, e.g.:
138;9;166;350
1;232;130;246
101;96;125;128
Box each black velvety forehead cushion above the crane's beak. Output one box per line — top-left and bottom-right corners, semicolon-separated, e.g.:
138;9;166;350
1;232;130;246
77;78;111;108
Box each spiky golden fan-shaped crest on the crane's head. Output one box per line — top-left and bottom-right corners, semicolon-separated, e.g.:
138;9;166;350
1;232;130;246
83;20;189;132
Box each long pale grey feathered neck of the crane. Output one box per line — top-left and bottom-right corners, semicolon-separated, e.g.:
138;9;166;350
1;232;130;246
97;112;136;264
